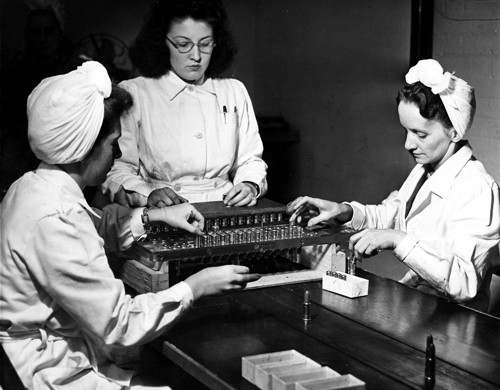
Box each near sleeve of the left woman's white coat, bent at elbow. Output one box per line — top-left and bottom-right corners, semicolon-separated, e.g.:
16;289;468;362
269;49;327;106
27;209;193;346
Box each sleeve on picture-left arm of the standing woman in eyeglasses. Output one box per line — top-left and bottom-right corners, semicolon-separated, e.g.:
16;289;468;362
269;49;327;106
103;83;154;206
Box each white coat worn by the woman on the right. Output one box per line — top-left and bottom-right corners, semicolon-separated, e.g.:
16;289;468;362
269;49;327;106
348;143;500;310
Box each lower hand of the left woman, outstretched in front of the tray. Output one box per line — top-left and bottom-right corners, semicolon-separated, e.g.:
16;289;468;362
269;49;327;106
185;265;261;299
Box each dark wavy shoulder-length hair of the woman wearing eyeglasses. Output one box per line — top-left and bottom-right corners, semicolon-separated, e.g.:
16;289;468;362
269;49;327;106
129;0;236;78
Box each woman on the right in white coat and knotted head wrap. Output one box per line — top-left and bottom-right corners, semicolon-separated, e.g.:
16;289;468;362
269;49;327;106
290;60;500;310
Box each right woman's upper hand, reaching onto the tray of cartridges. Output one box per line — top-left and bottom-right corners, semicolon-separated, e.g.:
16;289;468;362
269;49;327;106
286;196;352;228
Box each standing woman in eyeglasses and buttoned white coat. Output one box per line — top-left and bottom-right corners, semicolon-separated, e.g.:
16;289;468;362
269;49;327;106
104;0;267;207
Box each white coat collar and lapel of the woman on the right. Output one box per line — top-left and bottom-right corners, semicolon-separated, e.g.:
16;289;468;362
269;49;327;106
422;141;472;198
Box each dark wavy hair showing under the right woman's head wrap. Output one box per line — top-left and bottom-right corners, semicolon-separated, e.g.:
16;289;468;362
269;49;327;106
396;81;453;129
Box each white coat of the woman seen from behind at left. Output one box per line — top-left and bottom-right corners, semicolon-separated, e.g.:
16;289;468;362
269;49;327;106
0;163;193;390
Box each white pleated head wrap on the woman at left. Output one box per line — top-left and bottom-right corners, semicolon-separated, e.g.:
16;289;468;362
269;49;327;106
28;61;111;164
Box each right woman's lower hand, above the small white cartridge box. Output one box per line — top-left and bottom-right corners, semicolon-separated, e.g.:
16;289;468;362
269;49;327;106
349;229;406;258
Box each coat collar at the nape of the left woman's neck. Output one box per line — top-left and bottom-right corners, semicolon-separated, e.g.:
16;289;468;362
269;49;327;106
36;161;101;218
